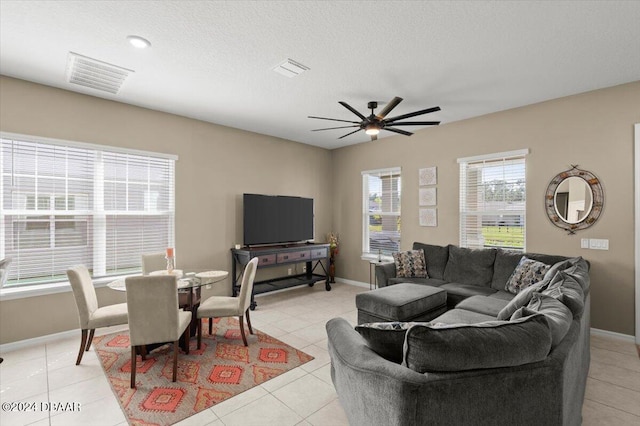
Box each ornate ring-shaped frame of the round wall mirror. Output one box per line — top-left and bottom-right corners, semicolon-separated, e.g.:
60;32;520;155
544;165;604;234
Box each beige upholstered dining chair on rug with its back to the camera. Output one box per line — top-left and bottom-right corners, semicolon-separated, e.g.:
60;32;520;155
124;275;191;388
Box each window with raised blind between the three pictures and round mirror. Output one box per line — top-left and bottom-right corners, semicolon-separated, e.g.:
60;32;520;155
458;150;529;251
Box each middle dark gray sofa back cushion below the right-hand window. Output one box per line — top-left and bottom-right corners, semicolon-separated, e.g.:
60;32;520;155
444;245;496;287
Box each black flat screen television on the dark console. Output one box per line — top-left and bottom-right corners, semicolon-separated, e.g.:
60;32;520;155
242;194;313;246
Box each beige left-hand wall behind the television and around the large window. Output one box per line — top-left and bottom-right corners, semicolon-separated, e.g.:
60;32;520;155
0;77;333;343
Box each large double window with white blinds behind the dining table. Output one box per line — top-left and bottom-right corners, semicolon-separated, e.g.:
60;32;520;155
0;134;176;287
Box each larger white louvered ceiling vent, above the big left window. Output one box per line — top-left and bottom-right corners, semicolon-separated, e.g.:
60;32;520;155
67;52;134;95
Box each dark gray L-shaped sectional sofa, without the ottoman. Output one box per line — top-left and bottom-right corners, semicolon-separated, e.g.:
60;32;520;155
326;243;590;426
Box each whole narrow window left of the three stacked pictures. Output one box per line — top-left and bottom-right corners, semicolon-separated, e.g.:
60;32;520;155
362;167;402;258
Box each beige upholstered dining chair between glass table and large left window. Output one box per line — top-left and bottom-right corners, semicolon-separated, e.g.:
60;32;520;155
67;265;127;365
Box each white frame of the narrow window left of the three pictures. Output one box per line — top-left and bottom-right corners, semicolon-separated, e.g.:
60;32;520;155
362;167;402;260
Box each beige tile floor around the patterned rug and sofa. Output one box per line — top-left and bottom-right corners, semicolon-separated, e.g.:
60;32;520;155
0;283;640;426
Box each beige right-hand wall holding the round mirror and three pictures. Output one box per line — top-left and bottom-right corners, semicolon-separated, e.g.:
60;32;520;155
332;82;640;335
